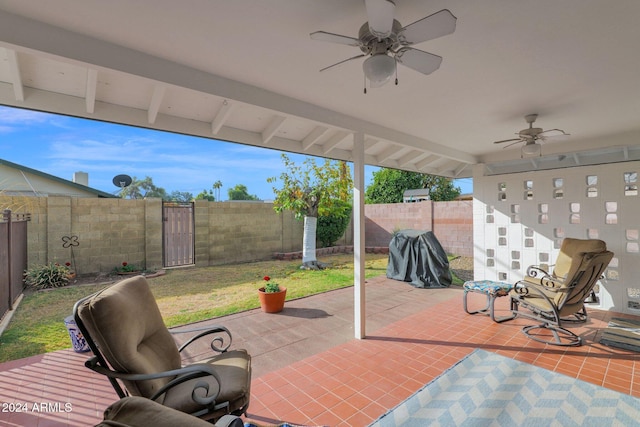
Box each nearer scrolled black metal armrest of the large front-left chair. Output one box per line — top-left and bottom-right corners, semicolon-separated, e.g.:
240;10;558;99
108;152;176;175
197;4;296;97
84;356;222;406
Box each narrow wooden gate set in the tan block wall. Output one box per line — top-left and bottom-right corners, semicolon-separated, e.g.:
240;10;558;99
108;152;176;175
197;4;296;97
162;202;195;267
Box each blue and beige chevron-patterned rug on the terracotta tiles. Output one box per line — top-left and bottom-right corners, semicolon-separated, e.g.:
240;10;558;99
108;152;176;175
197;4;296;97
371;349;640;427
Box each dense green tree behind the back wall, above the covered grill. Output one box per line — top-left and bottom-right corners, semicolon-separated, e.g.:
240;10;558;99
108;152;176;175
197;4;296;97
365;168;460;204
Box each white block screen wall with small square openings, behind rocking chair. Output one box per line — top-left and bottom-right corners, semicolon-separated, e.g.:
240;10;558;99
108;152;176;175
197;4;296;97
473;162;640;314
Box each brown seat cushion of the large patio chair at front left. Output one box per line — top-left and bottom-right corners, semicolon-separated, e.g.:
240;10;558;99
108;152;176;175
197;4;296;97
163;349;251;418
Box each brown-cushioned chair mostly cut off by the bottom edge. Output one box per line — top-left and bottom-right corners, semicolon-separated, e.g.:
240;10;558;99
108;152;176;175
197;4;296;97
95;396;244;427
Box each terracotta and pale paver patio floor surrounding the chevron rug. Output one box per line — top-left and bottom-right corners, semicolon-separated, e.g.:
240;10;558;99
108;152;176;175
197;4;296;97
0;277;640;426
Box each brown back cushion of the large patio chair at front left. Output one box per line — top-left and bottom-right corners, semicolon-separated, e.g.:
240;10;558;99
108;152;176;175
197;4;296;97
78;276;181;397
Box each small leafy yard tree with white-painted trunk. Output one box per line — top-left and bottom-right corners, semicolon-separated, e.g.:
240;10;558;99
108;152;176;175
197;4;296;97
267;154;353;269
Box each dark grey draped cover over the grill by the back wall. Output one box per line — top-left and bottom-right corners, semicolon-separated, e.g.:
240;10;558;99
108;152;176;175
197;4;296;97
387;230;451;288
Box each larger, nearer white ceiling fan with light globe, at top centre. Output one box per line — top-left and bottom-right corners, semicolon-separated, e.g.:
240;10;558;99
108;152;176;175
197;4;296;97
310;0;457;93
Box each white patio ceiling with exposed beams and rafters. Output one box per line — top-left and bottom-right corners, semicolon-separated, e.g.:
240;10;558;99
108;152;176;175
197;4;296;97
0;0;640;177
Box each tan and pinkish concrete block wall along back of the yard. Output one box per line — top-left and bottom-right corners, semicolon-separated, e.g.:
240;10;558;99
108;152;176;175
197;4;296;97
0;196;472;274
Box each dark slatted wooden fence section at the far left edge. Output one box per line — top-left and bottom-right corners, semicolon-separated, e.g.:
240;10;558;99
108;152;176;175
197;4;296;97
0;210;30;318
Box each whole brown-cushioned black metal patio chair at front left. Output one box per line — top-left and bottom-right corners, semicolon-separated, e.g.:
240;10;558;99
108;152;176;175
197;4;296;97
73;276;251;421
